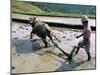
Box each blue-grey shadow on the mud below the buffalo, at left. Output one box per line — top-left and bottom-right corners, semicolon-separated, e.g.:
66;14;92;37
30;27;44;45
12;39;43;53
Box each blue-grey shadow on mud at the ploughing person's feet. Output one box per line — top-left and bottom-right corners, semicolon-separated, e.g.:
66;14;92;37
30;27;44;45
56;60;86;71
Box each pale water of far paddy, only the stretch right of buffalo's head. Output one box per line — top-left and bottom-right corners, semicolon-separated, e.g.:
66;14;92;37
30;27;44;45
38;17;96;26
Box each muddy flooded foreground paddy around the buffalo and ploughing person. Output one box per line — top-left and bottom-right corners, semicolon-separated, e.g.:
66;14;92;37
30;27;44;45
11;22;95;73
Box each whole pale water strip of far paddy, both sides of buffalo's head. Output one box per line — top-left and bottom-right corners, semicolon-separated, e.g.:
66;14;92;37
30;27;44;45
12;14;96;27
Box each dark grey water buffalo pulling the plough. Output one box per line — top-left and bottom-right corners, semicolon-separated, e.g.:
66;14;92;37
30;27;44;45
29;17;53;47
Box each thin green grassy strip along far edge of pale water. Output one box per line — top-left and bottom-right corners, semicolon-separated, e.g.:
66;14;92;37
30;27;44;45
13;12;95;19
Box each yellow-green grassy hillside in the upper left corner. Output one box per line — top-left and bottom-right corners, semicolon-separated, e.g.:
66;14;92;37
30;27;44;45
12;0;43;14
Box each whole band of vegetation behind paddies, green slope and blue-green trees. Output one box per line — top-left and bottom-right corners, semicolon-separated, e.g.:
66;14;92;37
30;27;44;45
12;0;96;18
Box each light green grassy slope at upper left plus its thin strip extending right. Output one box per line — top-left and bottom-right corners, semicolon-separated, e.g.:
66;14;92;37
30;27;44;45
12;0;95;18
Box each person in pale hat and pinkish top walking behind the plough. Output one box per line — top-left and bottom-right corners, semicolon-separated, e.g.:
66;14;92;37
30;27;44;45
75;15;91;61
